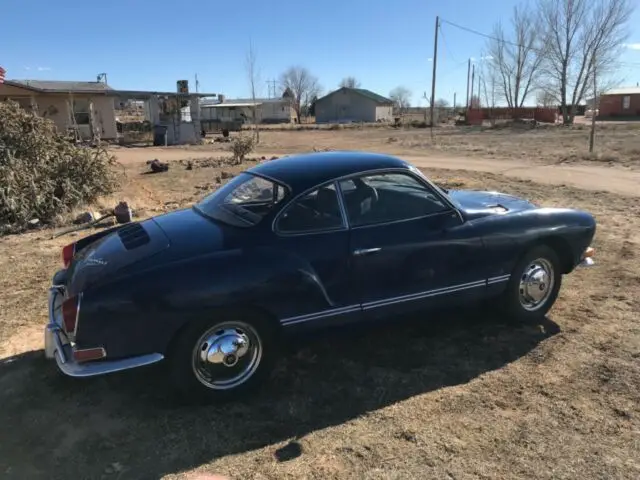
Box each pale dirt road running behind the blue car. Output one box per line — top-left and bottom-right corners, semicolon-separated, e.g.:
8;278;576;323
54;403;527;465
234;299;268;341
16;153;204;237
113;147;640;196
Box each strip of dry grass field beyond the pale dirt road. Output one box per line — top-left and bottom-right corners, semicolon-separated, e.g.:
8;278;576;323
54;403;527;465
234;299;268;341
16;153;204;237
211;122;640;168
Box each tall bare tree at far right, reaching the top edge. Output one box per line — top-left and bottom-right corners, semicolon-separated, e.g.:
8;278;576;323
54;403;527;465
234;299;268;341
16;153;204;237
538;0;633;124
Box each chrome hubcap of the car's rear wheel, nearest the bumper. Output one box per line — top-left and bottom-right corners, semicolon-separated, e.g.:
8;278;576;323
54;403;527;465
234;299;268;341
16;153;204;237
192;322;262;390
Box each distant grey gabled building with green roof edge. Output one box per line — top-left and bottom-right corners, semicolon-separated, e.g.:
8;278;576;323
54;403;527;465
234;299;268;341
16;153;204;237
315;87;393;123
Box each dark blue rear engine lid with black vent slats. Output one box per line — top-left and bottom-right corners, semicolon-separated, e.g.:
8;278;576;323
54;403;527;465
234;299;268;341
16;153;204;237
67;209;229;294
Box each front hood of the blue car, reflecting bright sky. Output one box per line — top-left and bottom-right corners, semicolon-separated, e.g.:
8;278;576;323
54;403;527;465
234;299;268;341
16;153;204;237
448;190;537;219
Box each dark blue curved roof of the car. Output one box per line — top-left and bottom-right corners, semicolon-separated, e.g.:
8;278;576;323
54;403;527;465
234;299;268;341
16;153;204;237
248;151;410;194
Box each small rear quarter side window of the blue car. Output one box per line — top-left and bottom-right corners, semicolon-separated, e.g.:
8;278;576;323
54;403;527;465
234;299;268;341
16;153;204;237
276;184;344;233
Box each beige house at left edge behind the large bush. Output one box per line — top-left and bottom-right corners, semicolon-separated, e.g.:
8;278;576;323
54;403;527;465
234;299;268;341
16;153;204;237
0;80;118;140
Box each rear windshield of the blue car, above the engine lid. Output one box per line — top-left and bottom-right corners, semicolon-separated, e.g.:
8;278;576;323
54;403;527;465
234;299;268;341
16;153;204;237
194;172;287;227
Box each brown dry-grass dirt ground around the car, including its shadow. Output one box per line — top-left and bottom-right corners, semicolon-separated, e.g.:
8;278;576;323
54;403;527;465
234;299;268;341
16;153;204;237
0;128;640;479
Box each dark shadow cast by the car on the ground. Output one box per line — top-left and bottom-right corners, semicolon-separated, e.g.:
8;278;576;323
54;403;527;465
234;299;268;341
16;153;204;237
0;311;560;478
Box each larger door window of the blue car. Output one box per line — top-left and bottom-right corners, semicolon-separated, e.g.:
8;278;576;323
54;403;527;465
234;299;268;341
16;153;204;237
340;173;450;227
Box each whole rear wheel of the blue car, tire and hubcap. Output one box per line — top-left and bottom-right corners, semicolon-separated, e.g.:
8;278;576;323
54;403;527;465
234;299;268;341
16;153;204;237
169;313;276;402
